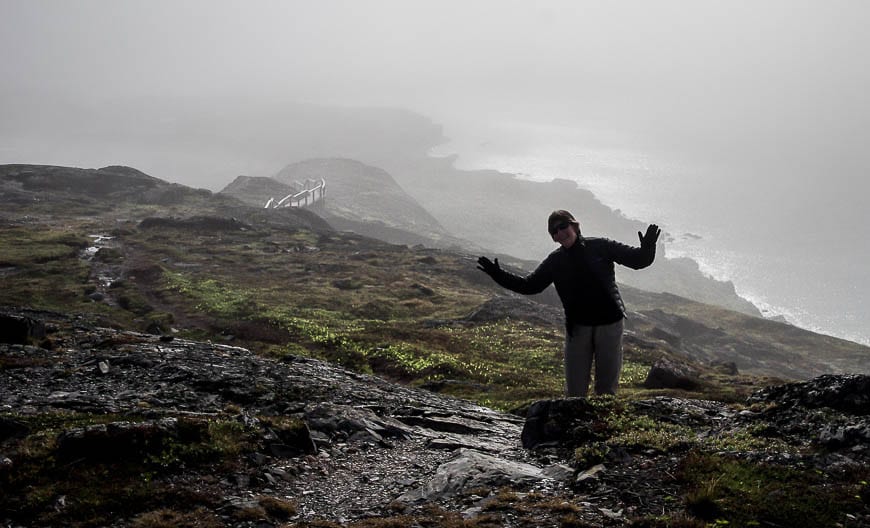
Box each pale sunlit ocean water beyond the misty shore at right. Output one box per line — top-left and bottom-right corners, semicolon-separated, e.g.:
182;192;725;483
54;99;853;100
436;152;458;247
430;120;870;346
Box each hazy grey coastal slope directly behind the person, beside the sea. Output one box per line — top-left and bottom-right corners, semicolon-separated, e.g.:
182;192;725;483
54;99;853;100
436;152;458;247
378;129;763;317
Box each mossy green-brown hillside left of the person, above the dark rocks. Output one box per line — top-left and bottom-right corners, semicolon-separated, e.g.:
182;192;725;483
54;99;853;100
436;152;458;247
0;163;792;408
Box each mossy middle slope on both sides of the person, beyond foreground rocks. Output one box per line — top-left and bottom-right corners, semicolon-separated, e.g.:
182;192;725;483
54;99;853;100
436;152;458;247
0;166;868;384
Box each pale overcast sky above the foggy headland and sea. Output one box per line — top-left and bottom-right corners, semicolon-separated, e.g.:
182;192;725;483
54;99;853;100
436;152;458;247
0;0;870;172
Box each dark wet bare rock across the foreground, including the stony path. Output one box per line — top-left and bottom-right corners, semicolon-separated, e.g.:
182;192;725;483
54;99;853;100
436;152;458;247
0;313;870;526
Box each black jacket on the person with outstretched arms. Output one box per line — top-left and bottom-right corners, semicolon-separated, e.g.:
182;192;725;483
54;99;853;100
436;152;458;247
493;237;656;331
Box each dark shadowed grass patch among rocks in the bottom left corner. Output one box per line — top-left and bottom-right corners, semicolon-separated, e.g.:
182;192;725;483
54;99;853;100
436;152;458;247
0;414;257;526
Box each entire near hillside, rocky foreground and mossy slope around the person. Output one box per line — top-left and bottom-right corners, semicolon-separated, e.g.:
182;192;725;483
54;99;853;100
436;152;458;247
0;166;870;528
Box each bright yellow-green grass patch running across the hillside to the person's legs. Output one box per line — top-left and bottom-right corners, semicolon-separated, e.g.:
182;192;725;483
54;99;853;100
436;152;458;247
157;271;668;410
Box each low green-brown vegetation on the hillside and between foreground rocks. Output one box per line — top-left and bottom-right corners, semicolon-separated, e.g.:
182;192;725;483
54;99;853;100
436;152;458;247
0;174;870;528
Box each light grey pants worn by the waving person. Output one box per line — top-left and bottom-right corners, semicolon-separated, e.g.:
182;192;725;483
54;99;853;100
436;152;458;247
565;319;622;397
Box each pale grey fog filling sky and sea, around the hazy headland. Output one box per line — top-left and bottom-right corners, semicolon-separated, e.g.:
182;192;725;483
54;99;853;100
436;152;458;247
0;0;870;343
